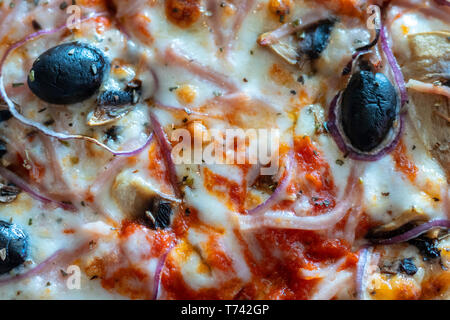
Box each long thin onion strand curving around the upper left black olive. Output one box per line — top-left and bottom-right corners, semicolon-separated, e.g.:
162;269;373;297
0;13;150;156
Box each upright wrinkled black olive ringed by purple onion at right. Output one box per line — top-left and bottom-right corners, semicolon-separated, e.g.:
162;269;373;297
341;71;398;151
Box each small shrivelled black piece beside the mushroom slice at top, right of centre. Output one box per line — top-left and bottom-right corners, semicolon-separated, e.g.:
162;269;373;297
299;20;335;59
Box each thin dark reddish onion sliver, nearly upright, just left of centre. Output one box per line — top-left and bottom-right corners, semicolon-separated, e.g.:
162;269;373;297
150;113;181;198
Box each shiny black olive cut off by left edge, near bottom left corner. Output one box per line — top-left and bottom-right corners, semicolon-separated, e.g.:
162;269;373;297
0;220;28;274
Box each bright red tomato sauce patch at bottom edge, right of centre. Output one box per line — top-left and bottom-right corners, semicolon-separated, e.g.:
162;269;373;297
236;229;358;300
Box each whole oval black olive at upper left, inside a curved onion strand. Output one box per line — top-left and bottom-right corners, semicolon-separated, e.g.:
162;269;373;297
28;42;109;104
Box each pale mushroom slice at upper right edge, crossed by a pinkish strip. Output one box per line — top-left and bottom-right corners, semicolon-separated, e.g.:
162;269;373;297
403;31;450;181
